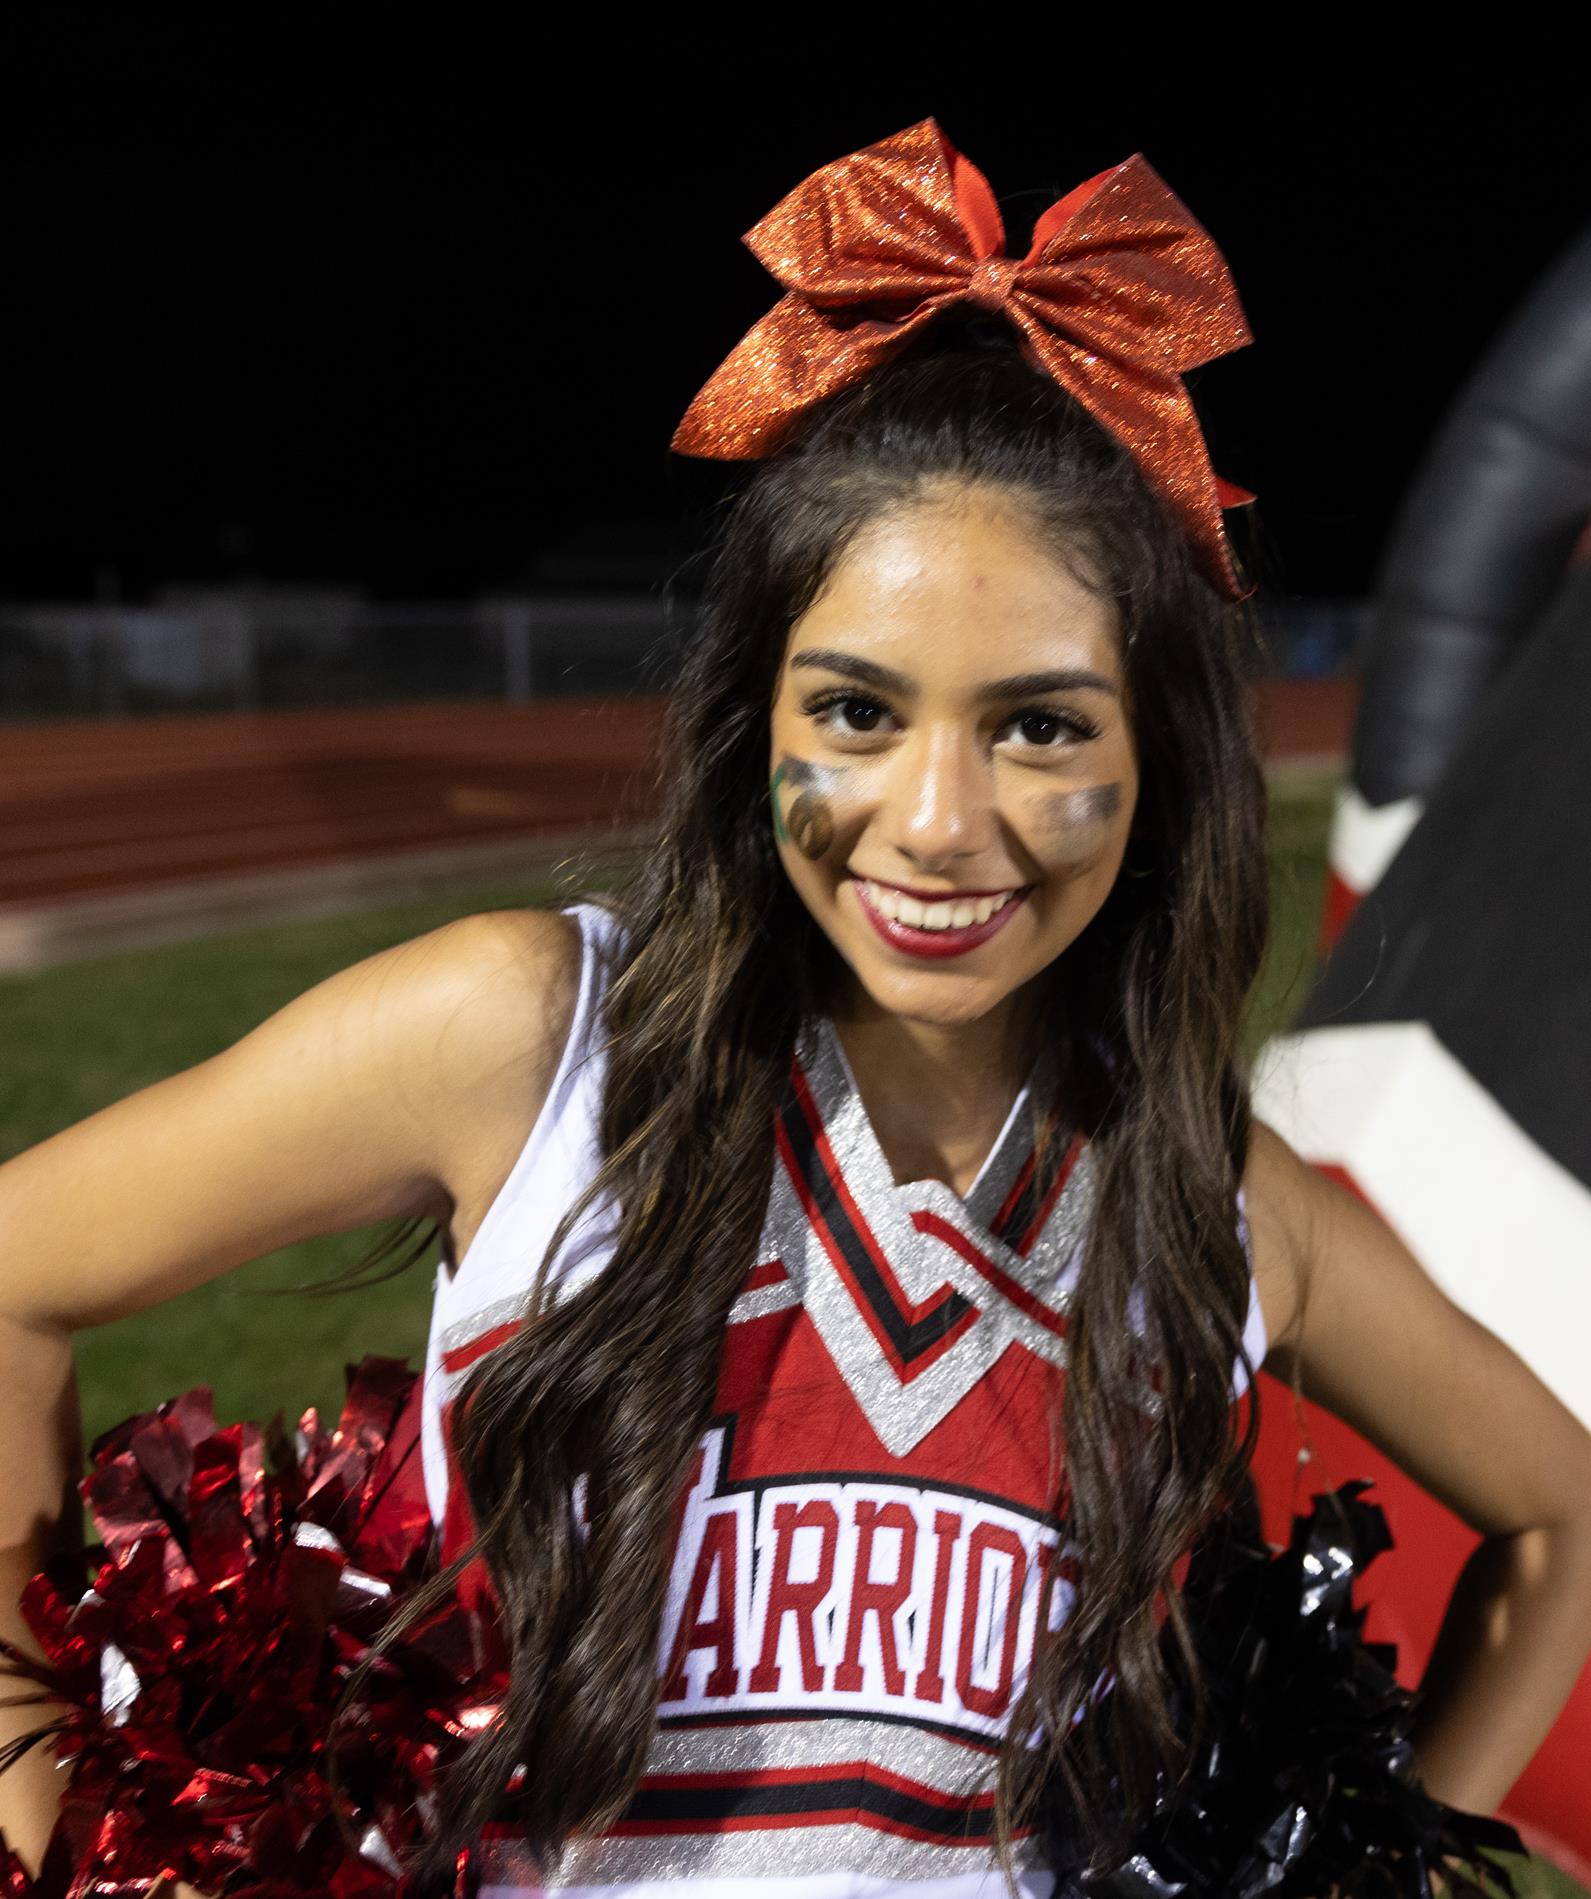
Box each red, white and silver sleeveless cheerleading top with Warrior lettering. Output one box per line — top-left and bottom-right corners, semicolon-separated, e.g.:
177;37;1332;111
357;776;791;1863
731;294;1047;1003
421;904;1266;1899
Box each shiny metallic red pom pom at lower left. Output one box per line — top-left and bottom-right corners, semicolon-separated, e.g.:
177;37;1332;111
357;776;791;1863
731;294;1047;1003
0;1358;507;1899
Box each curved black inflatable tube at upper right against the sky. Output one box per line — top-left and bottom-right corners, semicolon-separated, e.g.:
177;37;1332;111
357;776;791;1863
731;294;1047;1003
1352;230;1591;805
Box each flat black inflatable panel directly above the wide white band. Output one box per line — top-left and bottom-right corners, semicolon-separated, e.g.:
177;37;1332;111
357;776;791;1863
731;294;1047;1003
1293;566;1591;1187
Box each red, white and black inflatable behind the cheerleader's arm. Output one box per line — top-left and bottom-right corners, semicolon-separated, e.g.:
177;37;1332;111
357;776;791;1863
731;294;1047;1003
1255;230;1591;1888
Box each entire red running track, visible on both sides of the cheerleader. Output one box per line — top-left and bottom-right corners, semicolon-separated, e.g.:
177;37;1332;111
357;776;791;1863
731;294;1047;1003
0;680;1354;968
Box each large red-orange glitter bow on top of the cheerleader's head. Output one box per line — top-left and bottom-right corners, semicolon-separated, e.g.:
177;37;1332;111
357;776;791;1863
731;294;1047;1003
672;118;1253;600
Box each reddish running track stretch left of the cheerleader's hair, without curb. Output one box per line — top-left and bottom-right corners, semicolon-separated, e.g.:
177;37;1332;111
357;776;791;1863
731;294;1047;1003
0;699;657;904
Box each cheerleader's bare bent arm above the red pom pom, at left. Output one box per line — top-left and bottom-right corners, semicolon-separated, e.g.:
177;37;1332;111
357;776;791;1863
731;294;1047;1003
0;912;579;1861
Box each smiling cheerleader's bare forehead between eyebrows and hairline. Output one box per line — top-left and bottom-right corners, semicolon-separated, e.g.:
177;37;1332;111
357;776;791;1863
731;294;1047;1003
786;490;1120;680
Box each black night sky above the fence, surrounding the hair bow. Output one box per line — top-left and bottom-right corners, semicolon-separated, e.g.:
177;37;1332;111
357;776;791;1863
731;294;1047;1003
0;18;1591;600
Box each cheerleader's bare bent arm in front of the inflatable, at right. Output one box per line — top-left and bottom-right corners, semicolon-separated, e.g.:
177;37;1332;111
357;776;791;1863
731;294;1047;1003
1245;1124;1591;1814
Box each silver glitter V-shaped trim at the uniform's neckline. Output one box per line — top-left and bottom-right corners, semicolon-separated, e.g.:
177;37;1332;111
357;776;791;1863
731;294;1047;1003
759;1020;1090;1457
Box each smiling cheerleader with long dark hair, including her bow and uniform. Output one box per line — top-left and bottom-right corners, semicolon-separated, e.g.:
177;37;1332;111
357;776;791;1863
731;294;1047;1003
0;120;1591;1899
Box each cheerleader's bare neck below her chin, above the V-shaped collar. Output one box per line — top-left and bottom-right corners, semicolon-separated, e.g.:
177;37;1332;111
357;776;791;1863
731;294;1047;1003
833;993;1033;1193
